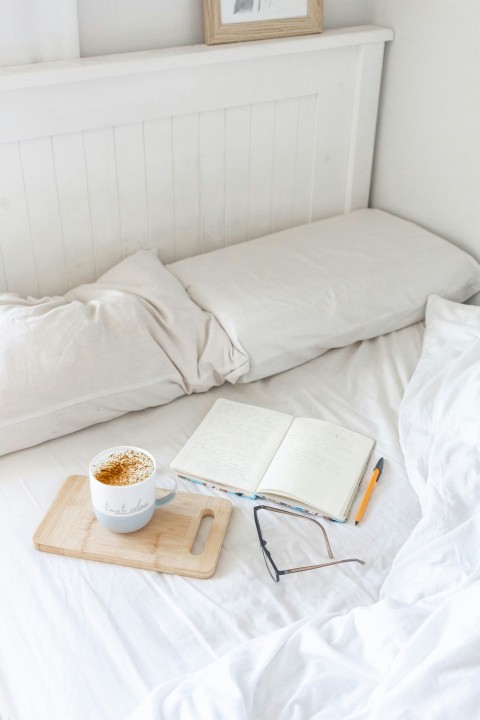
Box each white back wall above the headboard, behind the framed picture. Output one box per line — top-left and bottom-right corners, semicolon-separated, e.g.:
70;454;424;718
77;0;374;57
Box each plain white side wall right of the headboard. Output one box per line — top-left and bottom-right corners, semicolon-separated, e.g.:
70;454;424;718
371;0;480;260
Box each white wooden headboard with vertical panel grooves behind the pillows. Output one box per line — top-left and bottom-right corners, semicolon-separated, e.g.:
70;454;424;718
0;27;393;297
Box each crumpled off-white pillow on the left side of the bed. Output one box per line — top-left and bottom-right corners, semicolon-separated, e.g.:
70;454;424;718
0;251;248;455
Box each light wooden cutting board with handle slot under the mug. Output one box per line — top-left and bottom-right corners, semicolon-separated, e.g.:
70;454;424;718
33;475;232;578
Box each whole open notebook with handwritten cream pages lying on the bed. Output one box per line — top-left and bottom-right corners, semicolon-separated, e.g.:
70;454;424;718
171;398;375;522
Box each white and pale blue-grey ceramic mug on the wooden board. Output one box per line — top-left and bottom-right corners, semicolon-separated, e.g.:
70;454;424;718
89;445;177;533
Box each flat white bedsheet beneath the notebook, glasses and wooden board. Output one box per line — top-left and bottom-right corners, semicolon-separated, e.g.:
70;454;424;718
0;324;423;720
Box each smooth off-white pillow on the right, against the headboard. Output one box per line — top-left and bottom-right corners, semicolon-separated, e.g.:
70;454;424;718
167;210;480;382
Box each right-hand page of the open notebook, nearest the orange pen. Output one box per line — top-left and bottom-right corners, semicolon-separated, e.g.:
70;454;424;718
259;418;374;519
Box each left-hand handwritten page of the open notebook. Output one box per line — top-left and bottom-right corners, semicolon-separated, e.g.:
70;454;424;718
171;398;292;493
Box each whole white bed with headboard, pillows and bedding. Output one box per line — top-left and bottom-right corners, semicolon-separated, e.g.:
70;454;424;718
0;21;480;720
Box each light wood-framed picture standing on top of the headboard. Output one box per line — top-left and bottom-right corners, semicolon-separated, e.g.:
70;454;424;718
203;0;323;45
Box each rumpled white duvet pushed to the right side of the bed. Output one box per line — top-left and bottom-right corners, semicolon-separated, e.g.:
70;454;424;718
131;296;480;720
